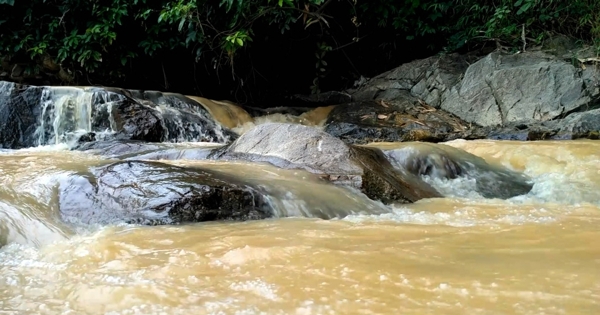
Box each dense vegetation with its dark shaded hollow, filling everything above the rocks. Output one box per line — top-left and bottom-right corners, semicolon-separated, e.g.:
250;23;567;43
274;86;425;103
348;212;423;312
0;0;600;102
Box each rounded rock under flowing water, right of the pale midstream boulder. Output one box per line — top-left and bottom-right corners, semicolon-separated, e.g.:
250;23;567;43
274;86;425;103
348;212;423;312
384;143;533;199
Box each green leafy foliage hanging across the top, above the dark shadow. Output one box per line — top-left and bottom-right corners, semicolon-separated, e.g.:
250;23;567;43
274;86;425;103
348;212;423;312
0;0;600;87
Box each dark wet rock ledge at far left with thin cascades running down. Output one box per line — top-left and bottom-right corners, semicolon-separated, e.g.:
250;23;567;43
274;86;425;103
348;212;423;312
0;82;237;148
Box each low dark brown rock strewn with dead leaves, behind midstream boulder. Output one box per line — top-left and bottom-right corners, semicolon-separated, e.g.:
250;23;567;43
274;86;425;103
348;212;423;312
325;91;468;144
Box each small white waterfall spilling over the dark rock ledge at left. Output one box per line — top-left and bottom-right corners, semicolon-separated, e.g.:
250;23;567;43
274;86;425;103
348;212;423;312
36;88;125;146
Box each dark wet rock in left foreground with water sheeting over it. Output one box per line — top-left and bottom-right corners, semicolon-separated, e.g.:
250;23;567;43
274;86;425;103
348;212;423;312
59;161;272;225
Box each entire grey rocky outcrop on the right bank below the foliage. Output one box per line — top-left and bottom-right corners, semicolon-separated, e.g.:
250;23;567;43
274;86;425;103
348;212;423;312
342;51;600;142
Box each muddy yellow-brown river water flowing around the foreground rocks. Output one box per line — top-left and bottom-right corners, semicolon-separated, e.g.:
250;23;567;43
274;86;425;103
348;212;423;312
0;141;600;314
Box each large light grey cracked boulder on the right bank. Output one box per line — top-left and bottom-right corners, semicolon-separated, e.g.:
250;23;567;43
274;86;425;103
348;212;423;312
441;53;593;126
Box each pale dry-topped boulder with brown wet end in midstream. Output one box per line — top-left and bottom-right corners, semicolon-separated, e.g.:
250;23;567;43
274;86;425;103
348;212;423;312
209;123;441;203
